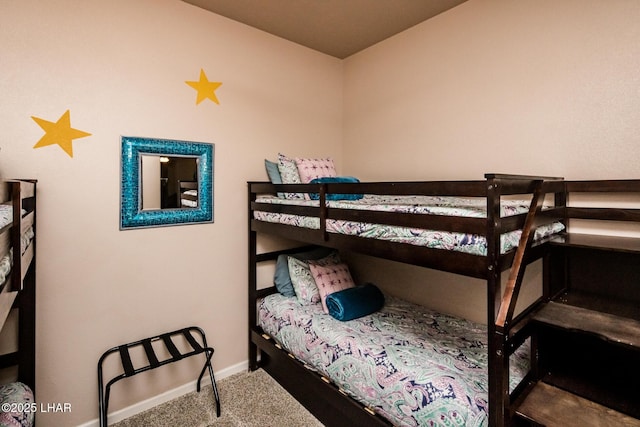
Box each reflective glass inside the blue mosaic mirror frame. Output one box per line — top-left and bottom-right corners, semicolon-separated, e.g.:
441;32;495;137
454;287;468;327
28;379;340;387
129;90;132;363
140;154;199;210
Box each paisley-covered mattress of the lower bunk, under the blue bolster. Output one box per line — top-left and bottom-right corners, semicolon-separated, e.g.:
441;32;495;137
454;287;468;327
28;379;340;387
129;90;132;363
259;294;529;427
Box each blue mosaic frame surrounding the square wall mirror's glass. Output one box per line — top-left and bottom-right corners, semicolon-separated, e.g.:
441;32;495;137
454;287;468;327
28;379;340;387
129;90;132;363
120;136;214;230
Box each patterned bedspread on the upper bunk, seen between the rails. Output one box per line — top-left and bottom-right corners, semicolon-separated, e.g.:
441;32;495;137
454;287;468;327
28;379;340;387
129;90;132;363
254;195;564;256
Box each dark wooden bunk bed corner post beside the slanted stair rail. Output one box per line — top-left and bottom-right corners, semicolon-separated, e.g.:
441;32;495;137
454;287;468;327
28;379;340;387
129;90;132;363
485;174;509;427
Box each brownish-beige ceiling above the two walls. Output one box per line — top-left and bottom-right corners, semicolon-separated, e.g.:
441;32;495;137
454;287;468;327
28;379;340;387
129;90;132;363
183;0;466;59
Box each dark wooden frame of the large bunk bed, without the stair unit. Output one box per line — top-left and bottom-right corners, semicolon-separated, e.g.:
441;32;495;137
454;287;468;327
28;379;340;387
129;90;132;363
248;174;566;427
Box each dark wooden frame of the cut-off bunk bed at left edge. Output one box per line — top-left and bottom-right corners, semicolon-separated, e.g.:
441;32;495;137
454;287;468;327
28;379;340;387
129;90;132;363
0;180;36;395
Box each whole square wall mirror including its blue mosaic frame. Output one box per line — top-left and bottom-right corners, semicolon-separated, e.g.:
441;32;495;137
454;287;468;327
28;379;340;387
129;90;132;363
120;136;214;230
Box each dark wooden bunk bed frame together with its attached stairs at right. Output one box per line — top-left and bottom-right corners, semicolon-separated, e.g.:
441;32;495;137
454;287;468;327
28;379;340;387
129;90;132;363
248;174;640;427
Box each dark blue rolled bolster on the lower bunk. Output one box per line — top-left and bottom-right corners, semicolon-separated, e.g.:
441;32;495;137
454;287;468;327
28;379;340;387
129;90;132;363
325;283;384;321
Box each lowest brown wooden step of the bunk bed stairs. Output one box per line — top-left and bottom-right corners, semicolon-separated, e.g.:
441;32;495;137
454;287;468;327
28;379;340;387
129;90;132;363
516;382;640;427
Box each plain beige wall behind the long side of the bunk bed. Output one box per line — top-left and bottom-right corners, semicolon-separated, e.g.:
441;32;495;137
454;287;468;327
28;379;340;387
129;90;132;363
344;0;640;321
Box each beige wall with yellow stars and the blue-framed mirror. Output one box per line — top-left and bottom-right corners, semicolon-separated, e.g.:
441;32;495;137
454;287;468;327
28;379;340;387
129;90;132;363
0;0;342;427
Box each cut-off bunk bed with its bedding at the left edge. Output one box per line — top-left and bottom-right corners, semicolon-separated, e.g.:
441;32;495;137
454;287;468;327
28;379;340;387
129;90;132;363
0;180;36;426
